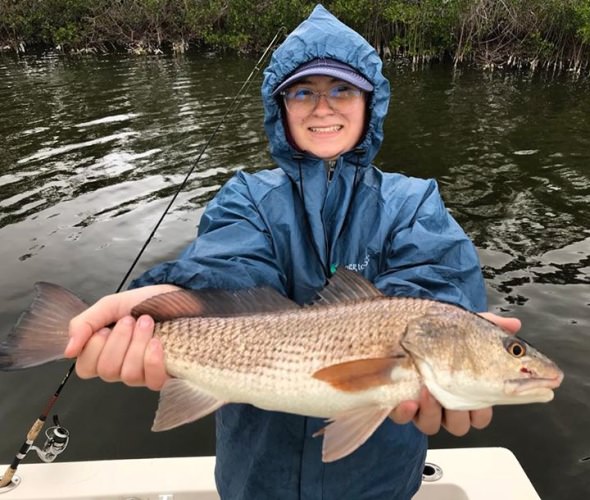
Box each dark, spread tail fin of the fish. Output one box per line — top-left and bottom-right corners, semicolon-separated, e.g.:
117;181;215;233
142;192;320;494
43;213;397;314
0;282;88;370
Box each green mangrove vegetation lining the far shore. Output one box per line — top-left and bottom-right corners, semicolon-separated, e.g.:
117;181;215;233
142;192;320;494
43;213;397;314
0;0;590;74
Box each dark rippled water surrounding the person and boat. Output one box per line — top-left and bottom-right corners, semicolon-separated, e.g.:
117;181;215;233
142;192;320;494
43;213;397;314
0;55;590;499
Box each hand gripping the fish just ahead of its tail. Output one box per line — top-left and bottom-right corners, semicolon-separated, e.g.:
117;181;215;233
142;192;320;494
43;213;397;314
65;285;177;390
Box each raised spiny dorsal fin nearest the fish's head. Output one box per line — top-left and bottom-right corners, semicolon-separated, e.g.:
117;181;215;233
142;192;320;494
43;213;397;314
312;267;383;306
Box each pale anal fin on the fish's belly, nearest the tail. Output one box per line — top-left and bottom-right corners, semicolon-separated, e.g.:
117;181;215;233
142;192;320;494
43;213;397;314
152;378;225;432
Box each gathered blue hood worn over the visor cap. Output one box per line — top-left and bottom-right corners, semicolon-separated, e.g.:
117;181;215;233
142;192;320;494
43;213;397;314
262;5;389;175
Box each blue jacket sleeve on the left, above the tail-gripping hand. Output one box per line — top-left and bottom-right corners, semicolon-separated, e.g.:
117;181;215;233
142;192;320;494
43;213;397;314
131;172;285;291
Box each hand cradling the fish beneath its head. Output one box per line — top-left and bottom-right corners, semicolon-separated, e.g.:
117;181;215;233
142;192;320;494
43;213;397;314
390;312;520;436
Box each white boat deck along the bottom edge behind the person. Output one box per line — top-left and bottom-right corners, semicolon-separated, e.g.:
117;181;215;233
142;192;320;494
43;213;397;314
0;448;540;500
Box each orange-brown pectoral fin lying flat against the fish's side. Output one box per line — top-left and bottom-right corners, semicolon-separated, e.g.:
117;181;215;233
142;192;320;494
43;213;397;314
312;353;406;392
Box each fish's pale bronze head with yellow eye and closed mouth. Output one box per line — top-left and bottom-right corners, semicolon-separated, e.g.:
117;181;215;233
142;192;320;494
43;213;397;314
401;310;563;410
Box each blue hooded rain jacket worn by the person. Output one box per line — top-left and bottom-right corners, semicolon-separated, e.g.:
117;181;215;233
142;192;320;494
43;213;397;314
132;6;486;500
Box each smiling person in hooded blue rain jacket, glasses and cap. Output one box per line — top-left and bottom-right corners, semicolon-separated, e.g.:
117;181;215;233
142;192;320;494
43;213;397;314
66;6;517;500
